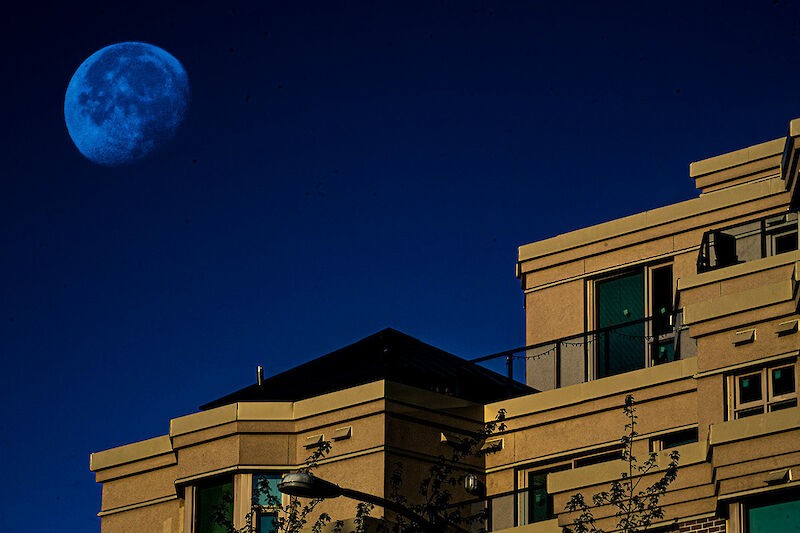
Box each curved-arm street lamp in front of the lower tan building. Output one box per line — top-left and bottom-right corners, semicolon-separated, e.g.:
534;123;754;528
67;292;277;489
278;472;467;533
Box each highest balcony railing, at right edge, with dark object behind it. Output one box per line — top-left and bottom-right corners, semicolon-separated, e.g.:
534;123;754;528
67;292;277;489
697;211;798;274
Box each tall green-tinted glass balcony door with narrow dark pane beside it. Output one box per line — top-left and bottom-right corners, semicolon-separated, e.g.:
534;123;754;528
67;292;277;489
590;264;676;378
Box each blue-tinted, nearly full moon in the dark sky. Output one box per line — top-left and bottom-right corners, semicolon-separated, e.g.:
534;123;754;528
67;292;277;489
64;42;190;167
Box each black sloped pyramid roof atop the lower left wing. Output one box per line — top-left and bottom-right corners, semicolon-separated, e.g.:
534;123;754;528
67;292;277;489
200;328;537;410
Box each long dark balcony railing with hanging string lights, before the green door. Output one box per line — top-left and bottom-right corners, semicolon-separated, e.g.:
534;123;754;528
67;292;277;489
472;311;697;390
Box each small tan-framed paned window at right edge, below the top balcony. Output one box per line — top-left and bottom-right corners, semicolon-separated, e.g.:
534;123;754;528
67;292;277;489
728;363;797;418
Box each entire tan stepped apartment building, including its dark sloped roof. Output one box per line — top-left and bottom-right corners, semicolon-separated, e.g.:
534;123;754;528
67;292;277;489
91;119;800;533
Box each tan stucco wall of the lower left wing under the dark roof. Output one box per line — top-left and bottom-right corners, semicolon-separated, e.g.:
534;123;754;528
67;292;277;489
91;382;483;532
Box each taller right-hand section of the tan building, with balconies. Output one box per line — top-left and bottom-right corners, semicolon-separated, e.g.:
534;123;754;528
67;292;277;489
496;120;800;533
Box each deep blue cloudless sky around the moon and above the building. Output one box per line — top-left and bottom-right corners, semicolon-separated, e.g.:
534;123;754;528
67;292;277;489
0;0;800;532
